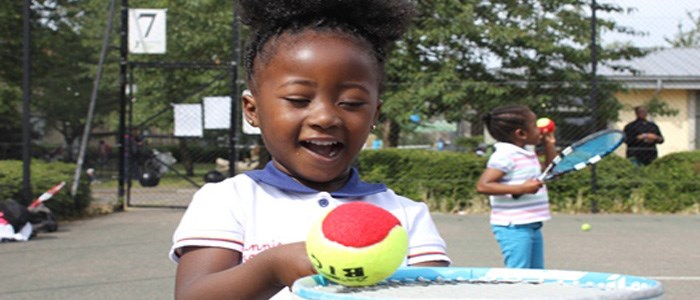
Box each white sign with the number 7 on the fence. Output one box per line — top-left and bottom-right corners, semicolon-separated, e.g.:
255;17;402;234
129;8;167;54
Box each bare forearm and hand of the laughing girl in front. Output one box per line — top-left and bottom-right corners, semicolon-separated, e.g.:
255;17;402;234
175;243;316;299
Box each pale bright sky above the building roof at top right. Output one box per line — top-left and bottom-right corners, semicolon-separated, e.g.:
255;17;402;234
597;0;700;48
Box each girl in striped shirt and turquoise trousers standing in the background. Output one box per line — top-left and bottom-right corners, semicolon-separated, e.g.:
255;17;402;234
476;105;556;269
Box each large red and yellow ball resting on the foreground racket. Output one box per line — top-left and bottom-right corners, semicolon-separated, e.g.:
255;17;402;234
306;202;408;286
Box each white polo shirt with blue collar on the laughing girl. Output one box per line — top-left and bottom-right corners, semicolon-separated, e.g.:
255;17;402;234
169;163;450;296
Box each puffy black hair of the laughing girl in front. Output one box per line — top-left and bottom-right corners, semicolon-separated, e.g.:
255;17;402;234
237;0;415;80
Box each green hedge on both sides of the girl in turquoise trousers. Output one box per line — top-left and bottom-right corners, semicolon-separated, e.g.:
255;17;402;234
360;149;700;213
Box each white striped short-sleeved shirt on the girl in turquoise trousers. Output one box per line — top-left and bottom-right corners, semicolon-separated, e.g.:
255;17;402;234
486;143;551;226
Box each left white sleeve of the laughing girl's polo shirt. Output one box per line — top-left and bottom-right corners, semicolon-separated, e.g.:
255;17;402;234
169;180;243;262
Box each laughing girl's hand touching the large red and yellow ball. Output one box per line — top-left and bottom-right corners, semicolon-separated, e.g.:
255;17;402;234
266;242;316;286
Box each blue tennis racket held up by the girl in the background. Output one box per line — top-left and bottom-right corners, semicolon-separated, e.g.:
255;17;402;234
513;129;625;199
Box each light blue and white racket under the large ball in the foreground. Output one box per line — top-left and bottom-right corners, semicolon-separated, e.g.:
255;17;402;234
292;267;664;299
